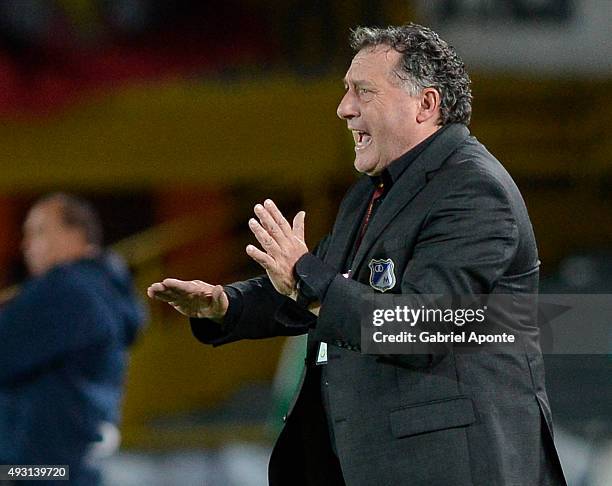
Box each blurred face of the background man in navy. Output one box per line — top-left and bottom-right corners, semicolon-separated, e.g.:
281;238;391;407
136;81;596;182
22;201;88;276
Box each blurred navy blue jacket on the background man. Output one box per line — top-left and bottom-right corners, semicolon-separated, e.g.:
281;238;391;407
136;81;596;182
0;252;144;464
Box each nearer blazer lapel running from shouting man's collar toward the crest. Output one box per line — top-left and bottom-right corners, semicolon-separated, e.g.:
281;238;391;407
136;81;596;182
352;124;470;275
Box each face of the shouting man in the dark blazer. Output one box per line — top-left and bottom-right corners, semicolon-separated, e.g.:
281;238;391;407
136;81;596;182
337;46;420;175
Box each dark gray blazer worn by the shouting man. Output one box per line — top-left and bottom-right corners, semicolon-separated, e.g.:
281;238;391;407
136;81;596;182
192;125;565;486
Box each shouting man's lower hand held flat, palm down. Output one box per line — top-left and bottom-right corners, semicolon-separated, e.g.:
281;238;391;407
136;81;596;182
147;278;229;322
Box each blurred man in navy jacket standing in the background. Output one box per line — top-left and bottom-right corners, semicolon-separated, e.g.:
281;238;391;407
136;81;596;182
0;194;144;485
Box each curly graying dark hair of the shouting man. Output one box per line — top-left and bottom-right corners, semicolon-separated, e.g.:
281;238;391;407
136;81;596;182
351;23;472;125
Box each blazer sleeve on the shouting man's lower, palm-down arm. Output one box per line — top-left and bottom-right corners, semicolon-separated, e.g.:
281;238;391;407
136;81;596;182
190;236;329;346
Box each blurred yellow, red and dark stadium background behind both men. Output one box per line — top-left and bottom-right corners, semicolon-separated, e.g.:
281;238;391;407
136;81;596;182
0;0;612;486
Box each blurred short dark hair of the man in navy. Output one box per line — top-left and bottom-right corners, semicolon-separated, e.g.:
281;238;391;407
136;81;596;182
36;192;103;248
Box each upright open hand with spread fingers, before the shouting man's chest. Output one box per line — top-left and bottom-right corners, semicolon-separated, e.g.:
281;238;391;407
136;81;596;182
246;199;308;296
